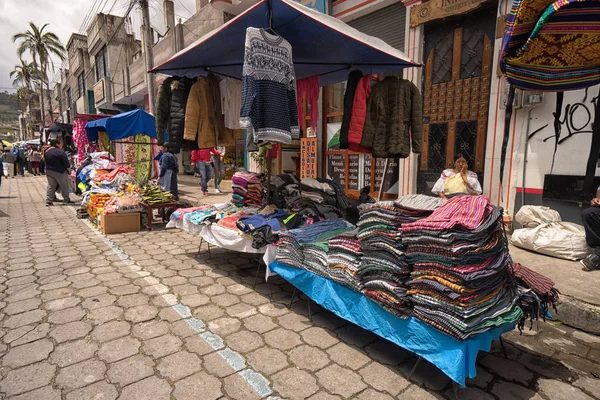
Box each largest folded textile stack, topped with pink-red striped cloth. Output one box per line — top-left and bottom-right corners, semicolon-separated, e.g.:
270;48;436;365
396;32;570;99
401;196;522;340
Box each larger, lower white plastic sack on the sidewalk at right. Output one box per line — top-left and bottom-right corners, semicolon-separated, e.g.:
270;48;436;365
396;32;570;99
511;222;588;261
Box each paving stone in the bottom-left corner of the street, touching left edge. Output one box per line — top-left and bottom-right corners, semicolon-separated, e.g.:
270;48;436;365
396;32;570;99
0;362;56;396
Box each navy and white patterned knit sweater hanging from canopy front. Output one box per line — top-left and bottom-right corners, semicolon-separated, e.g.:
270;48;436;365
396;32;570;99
240;28;299;144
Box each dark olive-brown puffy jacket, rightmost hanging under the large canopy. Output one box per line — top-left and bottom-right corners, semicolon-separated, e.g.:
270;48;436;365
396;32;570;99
360;76;423;158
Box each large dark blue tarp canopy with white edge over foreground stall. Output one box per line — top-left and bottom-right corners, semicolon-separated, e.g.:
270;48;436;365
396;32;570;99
152;0;419;86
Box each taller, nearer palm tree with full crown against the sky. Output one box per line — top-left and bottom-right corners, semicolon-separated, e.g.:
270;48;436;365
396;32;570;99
12;22;66;124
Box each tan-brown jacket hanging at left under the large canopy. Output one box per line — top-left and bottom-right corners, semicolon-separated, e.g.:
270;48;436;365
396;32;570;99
183;76;221;149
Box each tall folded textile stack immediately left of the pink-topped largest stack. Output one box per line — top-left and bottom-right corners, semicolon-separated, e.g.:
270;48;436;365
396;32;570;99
357;201;410;318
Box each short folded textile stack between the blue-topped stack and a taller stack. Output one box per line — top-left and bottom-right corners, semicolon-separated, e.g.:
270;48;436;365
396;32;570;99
327;235;363;292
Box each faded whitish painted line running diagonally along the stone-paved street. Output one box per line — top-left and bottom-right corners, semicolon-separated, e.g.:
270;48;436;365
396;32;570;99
73;209;281;400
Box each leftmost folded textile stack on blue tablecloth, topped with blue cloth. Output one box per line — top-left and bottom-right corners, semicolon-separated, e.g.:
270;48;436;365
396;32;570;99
277;219;354;278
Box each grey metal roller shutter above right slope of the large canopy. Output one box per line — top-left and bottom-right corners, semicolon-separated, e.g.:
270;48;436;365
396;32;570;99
348;2;406;51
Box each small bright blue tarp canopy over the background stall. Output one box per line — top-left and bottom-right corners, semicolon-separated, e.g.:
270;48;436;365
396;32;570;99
85;109;156;142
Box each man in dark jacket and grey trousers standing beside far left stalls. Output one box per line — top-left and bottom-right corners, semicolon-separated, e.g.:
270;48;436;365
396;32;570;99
43;139;72;206
